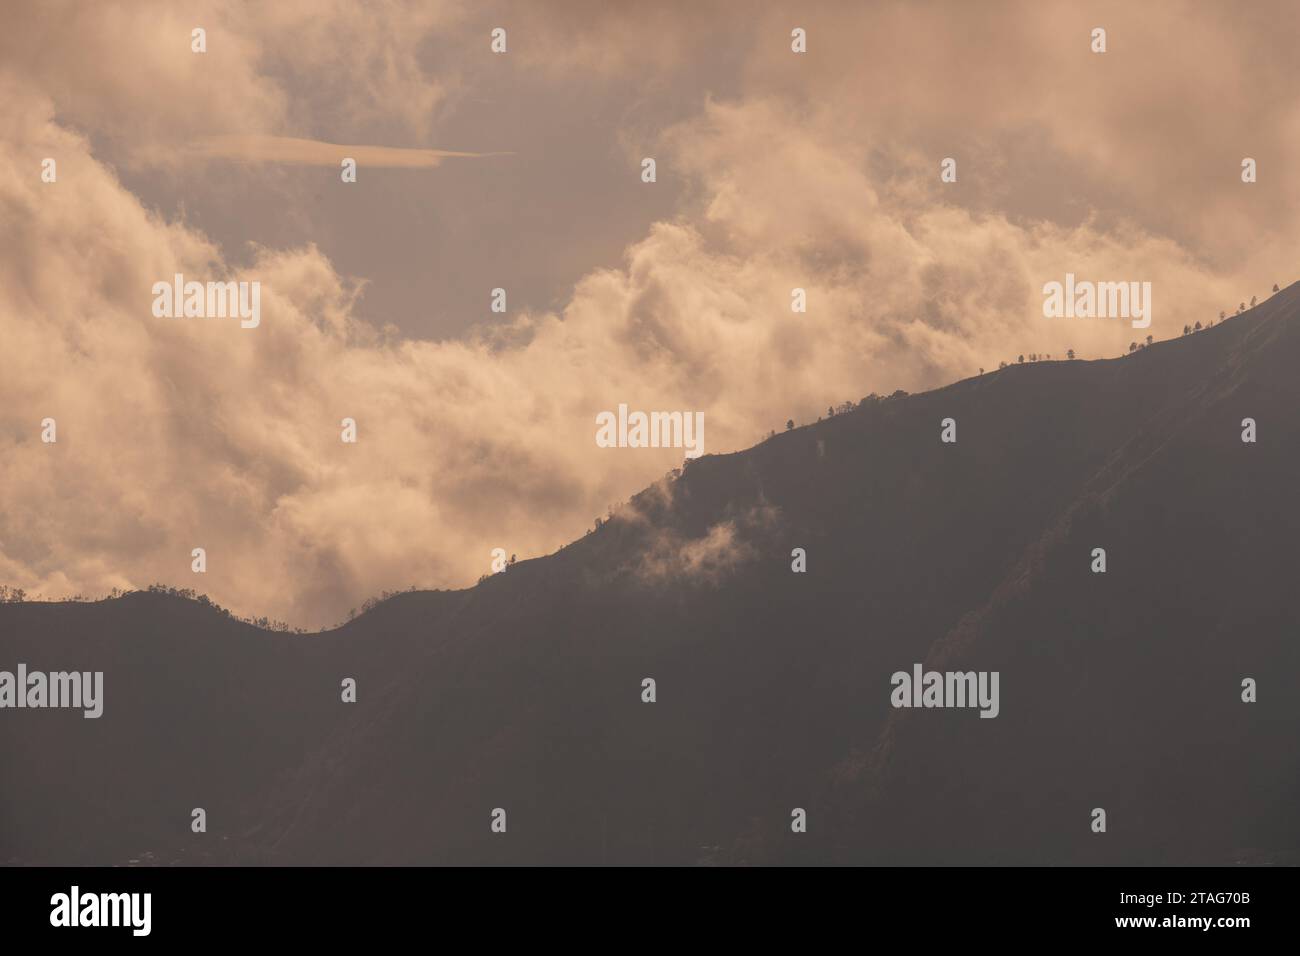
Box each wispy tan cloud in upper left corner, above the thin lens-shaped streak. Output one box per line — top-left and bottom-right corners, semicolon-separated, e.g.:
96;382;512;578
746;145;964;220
0;0;460;165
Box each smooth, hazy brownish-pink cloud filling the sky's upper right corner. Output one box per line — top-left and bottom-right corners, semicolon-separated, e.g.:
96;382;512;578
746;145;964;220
745;0;1300;277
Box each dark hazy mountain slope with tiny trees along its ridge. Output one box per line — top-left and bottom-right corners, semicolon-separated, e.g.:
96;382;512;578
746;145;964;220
0;286;1300;864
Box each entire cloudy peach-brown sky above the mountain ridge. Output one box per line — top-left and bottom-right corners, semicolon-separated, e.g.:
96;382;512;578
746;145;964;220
0;0;1300;626
